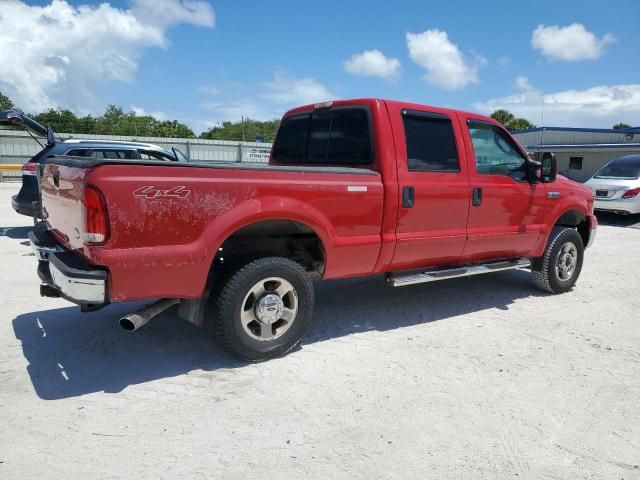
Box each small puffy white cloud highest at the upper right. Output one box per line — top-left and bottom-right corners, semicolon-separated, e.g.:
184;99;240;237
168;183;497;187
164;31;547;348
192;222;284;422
531;23;615;62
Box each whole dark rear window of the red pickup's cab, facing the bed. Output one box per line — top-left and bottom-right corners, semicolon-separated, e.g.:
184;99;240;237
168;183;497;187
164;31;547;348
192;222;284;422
272;106;373;167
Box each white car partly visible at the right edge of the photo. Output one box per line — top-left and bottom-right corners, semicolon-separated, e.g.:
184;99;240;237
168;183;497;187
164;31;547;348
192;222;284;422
586;155;640;215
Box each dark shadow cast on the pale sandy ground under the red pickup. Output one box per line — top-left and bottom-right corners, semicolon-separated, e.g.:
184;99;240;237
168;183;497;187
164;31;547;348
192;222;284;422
13;271;542;400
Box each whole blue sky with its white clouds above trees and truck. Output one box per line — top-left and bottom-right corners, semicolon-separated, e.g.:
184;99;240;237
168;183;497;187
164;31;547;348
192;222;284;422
0;0;640;132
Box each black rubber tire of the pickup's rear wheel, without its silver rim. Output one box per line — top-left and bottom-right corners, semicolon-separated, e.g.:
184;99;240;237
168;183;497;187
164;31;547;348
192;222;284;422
206;257;314;362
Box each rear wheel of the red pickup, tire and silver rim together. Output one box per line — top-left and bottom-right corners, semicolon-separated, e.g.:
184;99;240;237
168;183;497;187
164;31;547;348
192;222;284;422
208;257;314;361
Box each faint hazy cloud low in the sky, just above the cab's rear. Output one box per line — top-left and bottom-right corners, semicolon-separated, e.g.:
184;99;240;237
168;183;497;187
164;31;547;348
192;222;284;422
261;72;333;107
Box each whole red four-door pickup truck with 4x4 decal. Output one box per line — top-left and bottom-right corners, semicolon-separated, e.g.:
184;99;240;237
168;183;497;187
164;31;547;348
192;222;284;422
30;99;597;360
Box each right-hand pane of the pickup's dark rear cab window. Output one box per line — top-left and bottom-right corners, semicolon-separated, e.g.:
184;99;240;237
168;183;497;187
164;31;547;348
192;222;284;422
328;108;371;165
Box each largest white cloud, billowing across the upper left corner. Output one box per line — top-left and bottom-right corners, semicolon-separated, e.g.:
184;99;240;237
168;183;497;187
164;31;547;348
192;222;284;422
0;0;215;113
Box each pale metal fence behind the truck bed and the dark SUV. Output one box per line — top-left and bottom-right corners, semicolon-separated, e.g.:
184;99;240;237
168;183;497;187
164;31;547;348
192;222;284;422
0;130;271;180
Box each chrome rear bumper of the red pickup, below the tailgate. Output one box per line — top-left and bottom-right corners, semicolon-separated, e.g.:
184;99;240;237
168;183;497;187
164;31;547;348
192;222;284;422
29;230;108;306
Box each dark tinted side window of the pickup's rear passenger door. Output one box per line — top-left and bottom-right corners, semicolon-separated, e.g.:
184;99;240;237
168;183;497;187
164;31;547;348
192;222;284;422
404;113;460;172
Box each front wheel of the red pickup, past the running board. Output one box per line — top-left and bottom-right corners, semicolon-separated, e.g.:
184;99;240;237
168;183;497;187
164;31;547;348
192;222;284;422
531;227;584;293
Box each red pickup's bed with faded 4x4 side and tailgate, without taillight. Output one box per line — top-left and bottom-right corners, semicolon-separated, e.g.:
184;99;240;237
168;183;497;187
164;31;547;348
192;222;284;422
42;157;384;301
